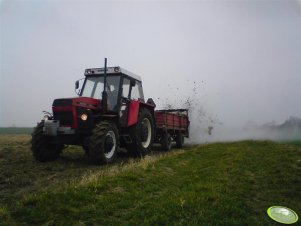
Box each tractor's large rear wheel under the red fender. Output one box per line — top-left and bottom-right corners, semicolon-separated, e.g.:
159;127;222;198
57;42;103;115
127;108;154;156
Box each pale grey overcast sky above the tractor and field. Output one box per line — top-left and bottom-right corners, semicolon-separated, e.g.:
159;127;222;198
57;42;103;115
0;0;301;126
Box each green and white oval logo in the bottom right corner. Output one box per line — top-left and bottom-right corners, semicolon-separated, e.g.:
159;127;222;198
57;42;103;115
267;206;298;224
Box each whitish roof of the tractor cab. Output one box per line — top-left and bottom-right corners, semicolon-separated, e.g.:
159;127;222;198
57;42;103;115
85;66;142;82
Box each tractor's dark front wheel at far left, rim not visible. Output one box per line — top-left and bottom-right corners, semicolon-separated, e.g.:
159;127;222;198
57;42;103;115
31;121;64;162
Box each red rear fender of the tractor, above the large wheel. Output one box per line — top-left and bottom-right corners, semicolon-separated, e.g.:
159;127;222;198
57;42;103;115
127;100;155;127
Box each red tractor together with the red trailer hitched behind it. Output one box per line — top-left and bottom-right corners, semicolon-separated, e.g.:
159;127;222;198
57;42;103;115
31;59;189;164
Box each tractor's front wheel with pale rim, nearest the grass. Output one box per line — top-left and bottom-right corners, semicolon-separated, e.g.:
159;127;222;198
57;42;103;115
89;121;119;164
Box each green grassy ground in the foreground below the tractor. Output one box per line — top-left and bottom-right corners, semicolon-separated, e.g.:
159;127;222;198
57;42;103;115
0;135;301;225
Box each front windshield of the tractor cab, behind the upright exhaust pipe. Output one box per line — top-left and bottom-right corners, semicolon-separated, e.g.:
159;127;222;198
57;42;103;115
81;75;120;111
